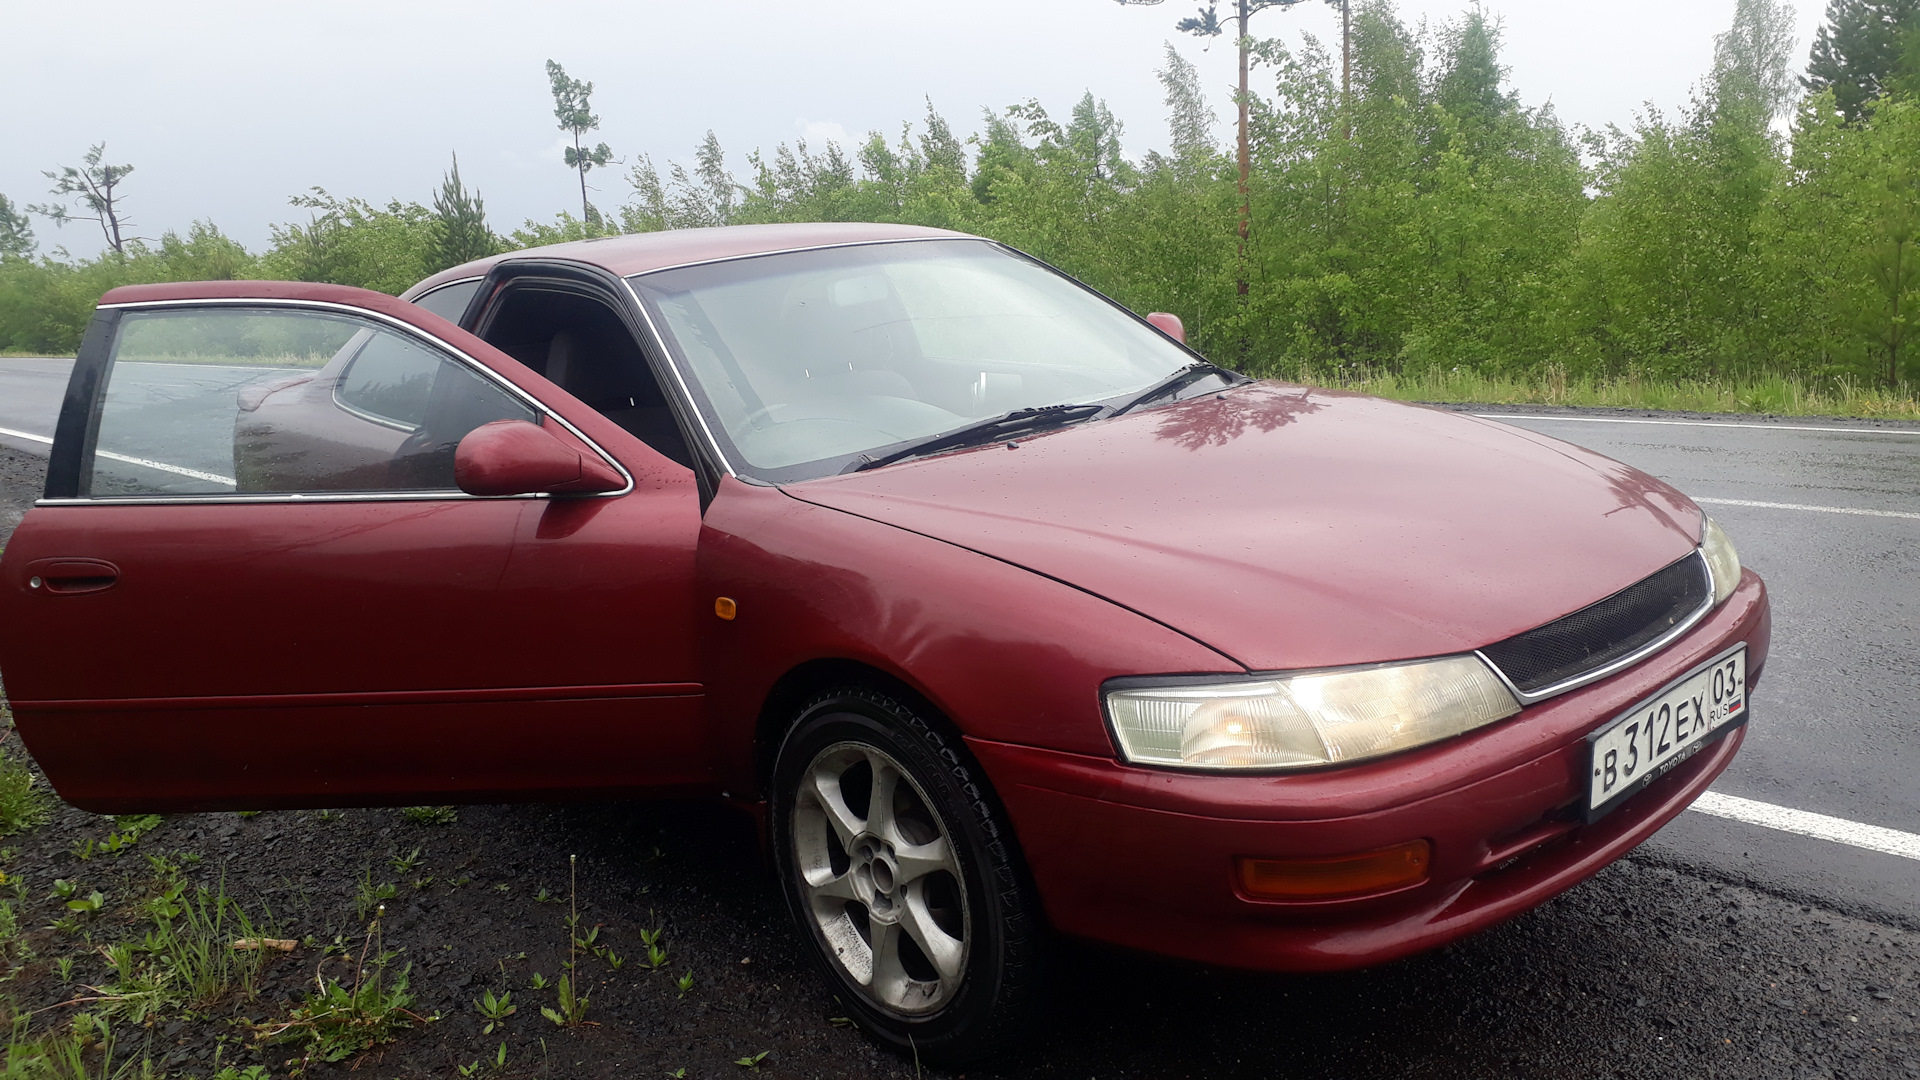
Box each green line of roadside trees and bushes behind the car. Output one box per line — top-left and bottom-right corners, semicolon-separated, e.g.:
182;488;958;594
0;0;1920;384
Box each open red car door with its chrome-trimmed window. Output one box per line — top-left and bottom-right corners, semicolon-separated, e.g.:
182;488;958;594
0;282;710;813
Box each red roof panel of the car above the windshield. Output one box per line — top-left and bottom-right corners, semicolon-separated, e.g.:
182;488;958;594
407;221;973;296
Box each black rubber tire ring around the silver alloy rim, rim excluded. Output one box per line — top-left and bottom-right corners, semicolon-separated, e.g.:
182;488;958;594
770;688;1037;1061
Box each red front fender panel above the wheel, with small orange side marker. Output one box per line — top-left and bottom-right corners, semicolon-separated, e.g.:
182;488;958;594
695;479;1244;792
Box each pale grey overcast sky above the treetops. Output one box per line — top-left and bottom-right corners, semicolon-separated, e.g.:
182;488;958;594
0;0;1824;254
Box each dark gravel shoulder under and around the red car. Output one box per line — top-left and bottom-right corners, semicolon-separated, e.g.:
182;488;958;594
0;441;1920;1080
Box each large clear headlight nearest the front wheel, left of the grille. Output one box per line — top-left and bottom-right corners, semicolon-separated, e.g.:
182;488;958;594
1106;655;1521;769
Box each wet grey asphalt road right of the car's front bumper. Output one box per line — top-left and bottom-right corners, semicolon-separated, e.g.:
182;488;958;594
1451;409;1920;926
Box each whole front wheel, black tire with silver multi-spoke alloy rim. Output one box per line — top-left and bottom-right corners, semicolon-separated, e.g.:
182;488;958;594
772;688;1041;1063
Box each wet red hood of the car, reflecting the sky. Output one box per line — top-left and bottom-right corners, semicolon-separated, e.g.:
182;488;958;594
785;382;1701;671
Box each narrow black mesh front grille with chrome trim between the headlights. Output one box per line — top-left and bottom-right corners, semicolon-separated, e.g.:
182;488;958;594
1480;553;1713;694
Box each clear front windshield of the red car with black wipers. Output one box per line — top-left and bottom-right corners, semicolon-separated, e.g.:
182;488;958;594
630;240;1194;480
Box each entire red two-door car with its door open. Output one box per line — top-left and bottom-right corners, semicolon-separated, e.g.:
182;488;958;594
0;225;1768;1059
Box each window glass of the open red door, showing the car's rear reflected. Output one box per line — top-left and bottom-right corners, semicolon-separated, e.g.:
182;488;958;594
79;307;538;498
